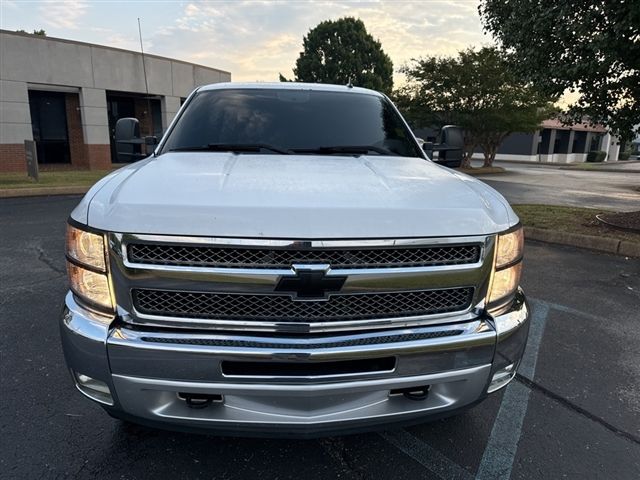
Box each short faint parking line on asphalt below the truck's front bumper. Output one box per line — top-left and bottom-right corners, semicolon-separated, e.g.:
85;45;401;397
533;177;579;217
380;430;473;480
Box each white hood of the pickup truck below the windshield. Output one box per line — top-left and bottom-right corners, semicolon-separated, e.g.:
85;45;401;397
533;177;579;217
72;152;518;239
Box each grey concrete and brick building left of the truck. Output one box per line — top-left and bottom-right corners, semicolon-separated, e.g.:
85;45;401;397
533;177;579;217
0;30;231;172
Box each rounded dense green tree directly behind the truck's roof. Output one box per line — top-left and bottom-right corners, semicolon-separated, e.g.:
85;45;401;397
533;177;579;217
280;17;393;93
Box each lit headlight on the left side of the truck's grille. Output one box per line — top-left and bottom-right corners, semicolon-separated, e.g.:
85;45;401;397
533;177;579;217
67;225;114;311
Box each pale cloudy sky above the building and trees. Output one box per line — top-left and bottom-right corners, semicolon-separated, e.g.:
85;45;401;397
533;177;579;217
0;0;492;82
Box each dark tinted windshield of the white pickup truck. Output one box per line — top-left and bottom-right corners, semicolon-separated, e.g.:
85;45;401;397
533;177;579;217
162;89;422;157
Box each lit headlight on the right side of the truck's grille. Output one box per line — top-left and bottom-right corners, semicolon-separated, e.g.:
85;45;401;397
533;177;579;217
488;227;524;307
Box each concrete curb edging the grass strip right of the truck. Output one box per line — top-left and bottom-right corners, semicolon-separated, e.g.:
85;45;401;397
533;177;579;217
524;227;640;258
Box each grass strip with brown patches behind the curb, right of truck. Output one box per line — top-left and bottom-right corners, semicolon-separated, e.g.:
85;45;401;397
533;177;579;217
513;205;640;243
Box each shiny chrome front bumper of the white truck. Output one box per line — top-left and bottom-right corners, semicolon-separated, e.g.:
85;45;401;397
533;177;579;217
60;291;529;436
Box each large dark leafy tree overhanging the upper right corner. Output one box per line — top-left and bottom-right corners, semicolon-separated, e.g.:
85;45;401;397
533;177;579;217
479;0;640;138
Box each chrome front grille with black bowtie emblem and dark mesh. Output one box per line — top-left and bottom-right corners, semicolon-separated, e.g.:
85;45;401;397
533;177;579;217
109;233;495;334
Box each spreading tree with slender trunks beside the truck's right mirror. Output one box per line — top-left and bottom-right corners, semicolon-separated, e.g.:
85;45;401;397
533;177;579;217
394;47;554;167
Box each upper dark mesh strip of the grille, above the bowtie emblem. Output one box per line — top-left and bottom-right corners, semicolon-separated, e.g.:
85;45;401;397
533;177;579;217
128;243;480;269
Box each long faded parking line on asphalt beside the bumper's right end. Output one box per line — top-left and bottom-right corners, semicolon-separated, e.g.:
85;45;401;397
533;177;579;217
476;300;549;480
